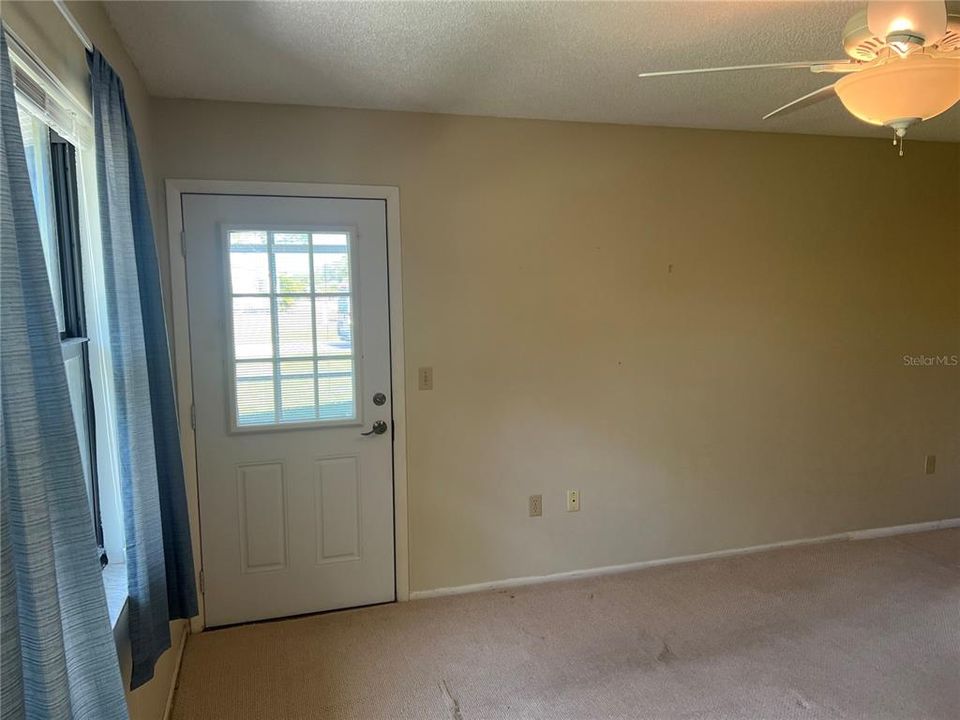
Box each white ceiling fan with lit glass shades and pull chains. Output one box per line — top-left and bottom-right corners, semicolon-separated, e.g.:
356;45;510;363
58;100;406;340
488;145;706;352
639;0;960;156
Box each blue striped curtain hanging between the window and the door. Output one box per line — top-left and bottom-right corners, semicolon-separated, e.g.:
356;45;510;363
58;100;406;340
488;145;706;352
87;50;197;688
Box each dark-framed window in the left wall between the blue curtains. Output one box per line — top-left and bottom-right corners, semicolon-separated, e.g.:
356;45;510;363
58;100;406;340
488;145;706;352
14;43;107;566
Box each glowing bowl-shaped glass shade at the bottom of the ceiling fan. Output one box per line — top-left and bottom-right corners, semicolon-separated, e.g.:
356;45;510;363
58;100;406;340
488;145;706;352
834;53;960;125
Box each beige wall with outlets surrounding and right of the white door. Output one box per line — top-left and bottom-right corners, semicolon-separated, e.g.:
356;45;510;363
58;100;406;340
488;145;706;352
153;100;960;590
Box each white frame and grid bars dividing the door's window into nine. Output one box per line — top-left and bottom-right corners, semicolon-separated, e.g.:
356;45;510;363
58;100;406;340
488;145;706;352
220;224;363;433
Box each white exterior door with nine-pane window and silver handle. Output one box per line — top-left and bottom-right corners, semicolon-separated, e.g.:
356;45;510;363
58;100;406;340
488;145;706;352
182;194;395;626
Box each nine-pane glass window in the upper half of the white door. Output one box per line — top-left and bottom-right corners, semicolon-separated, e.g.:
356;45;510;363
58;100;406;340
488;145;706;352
226;228;357;430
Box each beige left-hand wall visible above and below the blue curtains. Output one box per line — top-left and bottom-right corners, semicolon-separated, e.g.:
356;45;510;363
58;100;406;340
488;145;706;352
0;0;186;720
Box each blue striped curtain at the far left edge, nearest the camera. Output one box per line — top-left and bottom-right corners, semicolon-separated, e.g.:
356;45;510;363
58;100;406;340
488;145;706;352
0;27;127;720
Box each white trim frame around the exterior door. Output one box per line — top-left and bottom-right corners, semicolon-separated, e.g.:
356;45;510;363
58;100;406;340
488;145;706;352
165;179;410;632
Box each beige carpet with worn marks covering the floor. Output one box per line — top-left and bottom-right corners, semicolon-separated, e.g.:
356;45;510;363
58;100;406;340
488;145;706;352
173;530;960;720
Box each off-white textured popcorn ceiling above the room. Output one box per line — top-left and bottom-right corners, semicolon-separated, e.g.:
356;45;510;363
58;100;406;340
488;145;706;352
105;1;960;142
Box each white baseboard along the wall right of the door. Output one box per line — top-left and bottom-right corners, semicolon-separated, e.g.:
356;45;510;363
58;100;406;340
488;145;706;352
410;518;960;600
